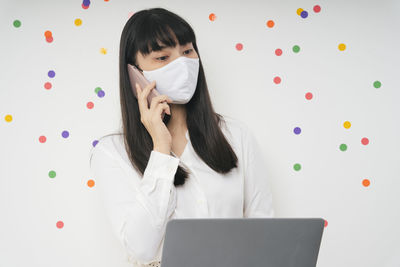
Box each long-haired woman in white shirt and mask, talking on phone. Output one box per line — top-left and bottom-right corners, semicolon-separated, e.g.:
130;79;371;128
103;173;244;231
91;8;274;266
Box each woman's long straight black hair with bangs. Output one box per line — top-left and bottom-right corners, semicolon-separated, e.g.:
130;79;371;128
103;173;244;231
90;8;238;186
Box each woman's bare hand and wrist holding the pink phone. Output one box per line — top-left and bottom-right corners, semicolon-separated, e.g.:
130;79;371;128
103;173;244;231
136;81;172;155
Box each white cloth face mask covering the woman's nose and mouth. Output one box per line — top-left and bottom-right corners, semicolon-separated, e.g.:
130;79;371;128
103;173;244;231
143;56;199;104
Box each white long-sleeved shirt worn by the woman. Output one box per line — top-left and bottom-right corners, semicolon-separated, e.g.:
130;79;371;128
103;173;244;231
91;116;274;266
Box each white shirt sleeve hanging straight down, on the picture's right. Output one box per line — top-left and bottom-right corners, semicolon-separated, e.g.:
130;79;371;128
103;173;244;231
243;125;275;218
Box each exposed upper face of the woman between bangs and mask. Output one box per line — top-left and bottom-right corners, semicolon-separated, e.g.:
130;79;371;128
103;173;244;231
136;38;199;71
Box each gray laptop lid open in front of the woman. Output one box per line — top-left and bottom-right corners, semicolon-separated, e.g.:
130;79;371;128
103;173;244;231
161;218;324;267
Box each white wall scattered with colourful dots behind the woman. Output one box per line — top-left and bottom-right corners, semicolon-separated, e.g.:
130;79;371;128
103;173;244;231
0;0;400;267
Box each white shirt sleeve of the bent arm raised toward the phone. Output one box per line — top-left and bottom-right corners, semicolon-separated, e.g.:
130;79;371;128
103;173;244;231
90;143;179;263
